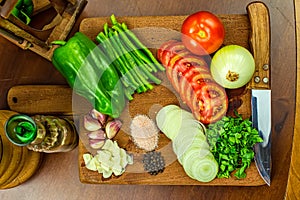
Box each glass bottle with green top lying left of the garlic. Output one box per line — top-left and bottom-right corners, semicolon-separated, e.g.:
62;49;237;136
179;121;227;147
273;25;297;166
5;114;78;153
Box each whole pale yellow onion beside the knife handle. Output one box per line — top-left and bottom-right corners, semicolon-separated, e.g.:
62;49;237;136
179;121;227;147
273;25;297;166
210;45;255;89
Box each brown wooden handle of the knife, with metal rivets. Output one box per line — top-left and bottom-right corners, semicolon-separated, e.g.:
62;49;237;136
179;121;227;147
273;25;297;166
247;2;271;89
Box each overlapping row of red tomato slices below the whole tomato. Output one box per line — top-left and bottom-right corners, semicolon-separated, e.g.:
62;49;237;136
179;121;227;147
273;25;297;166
157;40;228;124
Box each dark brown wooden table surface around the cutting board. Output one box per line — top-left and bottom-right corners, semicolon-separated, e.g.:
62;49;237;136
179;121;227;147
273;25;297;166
0;0;300;200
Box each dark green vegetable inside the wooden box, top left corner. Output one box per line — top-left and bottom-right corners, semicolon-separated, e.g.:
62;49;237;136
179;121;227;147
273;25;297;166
11;0;34;24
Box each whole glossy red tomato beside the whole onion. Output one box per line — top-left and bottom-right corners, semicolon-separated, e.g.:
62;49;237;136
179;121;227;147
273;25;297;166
181;11;225;55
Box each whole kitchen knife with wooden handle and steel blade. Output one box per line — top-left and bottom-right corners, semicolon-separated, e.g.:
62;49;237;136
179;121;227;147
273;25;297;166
247;3;272;186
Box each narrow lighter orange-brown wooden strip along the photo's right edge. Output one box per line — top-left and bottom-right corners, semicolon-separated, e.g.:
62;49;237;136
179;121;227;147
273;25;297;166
285;0;300;200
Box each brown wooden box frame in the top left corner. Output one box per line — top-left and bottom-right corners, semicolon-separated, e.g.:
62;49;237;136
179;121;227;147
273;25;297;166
0;0;86;60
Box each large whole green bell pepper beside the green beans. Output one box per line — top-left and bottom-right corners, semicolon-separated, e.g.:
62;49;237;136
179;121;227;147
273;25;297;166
52;32;125;118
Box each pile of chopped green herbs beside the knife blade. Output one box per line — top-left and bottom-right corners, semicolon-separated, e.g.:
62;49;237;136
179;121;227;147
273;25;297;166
206;112;263;179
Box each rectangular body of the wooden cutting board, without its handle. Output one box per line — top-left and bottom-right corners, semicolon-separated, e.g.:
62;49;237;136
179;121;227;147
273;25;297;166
79;2;265;186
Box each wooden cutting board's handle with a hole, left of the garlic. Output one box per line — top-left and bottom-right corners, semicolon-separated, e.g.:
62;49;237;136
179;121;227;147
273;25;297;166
7;85;88;115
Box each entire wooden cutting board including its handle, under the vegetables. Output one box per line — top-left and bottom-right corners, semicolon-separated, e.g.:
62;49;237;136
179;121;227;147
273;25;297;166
7;2;265;186
